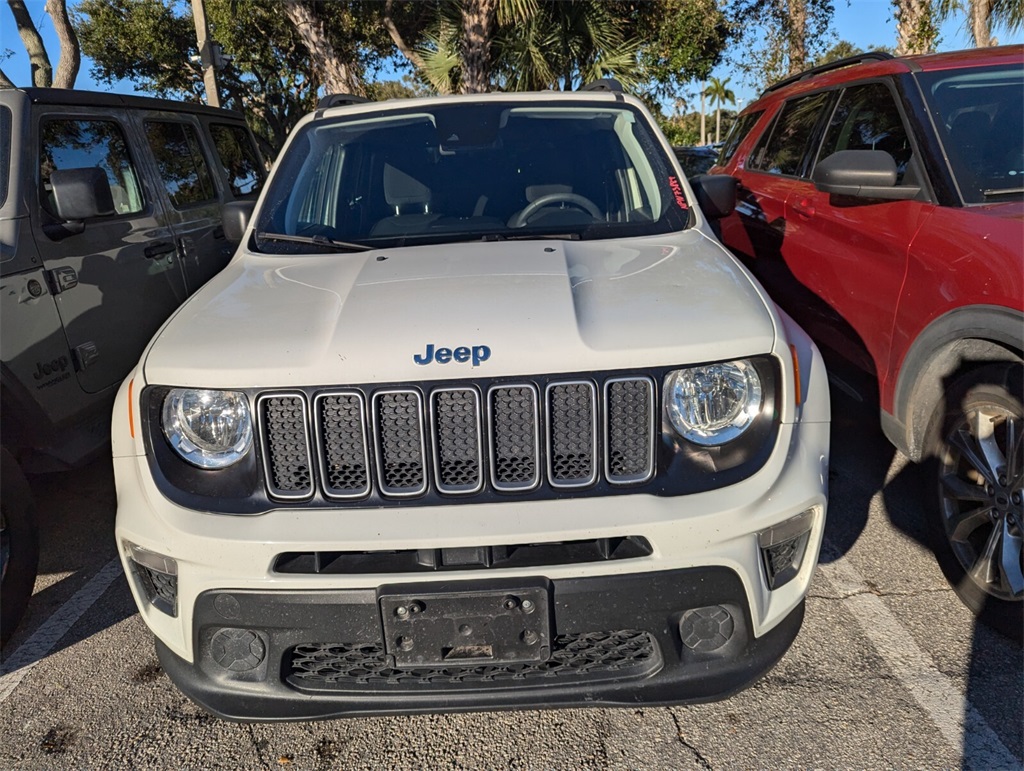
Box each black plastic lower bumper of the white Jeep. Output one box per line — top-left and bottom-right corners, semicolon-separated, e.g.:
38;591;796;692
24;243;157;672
157;567;804;721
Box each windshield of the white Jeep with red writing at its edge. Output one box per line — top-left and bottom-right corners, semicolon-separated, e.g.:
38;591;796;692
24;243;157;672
255;101;689;254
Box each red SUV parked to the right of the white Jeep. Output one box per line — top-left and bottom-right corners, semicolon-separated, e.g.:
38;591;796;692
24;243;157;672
713;46;1024;638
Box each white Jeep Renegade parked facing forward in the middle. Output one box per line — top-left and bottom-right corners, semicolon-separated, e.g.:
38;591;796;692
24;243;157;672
113;87;829;720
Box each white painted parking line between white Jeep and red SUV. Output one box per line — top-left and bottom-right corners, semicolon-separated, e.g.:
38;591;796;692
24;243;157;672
818;557;1022;771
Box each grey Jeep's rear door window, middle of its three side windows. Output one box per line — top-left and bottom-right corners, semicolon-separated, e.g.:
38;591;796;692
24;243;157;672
145;121;217;209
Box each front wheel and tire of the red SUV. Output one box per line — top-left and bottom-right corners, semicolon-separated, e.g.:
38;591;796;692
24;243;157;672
928;363;1024;642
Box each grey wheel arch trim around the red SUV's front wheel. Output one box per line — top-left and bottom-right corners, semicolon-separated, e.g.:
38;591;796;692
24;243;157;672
882;305;1024;461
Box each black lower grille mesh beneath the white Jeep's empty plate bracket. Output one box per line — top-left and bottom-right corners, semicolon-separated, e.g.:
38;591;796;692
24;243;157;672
288;630;662;690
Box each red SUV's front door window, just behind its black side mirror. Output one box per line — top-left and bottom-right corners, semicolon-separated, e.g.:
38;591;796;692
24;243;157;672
818;83;913;183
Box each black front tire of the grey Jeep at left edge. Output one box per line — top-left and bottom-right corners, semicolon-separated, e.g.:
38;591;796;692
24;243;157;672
0;449;39;644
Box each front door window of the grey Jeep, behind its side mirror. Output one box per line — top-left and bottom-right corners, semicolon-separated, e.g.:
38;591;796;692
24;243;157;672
39;120;143;215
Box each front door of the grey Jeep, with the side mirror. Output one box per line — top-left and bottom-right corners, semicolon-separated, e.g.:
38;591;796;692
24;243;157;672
32;106;187;393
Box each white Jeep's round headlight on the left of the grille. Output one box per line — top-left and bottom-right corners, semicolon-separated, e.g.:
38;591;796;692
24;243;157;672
163;388;253;469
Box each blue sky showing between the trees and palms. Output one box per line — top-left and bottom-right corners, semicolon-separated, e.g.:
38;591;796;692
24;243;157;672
0;0;1024;109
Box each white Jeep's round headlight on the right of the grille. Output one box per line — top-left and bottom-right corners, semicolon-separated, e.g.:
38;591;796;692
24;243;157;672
665;358;762;446
